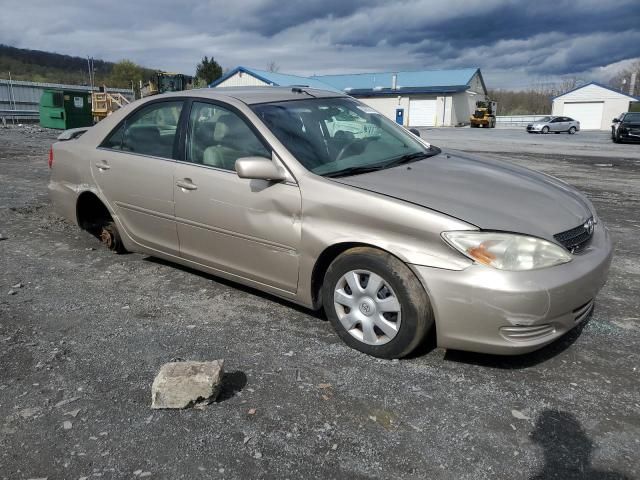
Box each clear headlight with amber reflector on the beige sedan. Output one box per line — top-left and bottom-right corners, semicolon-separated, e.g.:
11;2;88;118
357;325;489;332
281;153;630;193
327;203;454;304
442;231;572;271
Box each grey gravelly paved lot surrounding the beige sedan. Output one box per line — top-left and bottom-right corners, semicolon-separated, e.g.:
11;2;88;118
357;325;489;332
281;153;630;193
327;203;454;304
0;129;640;480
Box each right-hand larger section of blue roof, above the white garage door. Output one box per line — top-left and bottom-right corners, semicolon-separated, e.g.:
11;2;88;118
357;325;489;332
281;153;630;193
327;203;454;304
312;68;480;93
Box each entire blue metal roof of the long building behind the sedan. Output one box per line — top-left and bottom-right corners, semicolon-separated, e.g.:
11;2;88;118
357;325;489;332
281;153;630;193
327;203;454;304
209;67;486;96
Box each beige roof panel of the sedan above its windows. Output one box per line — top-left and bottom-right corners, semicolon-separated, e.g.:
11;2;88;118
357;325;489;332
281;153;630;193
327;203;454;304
153;86;347;105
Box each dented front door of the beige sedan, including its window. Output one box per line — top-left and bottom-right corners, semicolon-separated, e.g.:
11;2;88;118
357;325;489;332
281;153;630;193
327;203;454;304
174;102;301;292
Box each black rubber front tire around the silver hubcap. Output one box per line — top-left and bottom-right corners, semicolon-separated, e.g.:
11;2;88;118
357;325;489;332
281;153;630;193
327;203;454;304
322;247;434;358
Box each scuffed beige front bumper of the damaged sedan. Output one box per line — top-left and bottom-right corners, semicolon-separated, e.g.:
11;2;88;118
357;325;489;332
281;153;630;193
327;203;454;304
411;222;612;355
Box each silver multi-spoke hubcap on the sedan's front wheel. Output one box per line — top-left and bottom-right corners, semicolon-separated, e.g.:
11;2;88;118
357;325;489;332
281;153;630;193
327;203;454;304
333;270;401;345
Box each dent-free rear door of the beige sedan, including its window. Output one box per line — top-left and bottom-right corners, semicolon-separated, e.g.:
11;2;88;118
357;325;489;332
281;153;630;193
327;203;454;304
91;99;184;255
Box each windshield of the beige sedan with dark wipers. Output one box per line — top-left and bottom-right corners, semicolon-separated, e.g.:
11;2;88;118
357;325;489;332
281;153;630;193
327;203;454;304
252;98;440;175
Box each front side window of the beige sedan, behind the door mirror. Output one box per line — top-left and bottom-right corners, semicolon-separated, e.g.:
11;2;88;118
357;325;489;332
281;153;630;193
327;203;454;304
186;102;271;171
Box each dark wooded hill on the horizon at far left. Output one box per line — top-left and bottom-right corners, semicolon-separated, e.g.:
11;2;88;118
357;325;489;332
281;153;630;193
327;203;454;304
0;44;153;86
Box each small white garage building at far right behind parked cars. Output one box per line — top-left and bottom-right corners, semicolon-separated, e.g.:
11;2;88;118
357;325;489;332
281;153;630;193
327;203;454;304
552;82;639;130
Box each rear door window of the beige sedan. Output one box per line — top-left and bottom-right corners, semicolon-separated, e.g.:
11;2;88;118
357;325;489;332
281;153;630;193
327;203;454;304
100;101;183;158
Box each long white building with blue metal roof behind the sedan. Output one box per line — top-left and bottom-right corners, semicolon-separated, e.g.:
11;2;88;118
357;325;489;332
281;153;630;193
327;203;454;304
209;67;487;127
